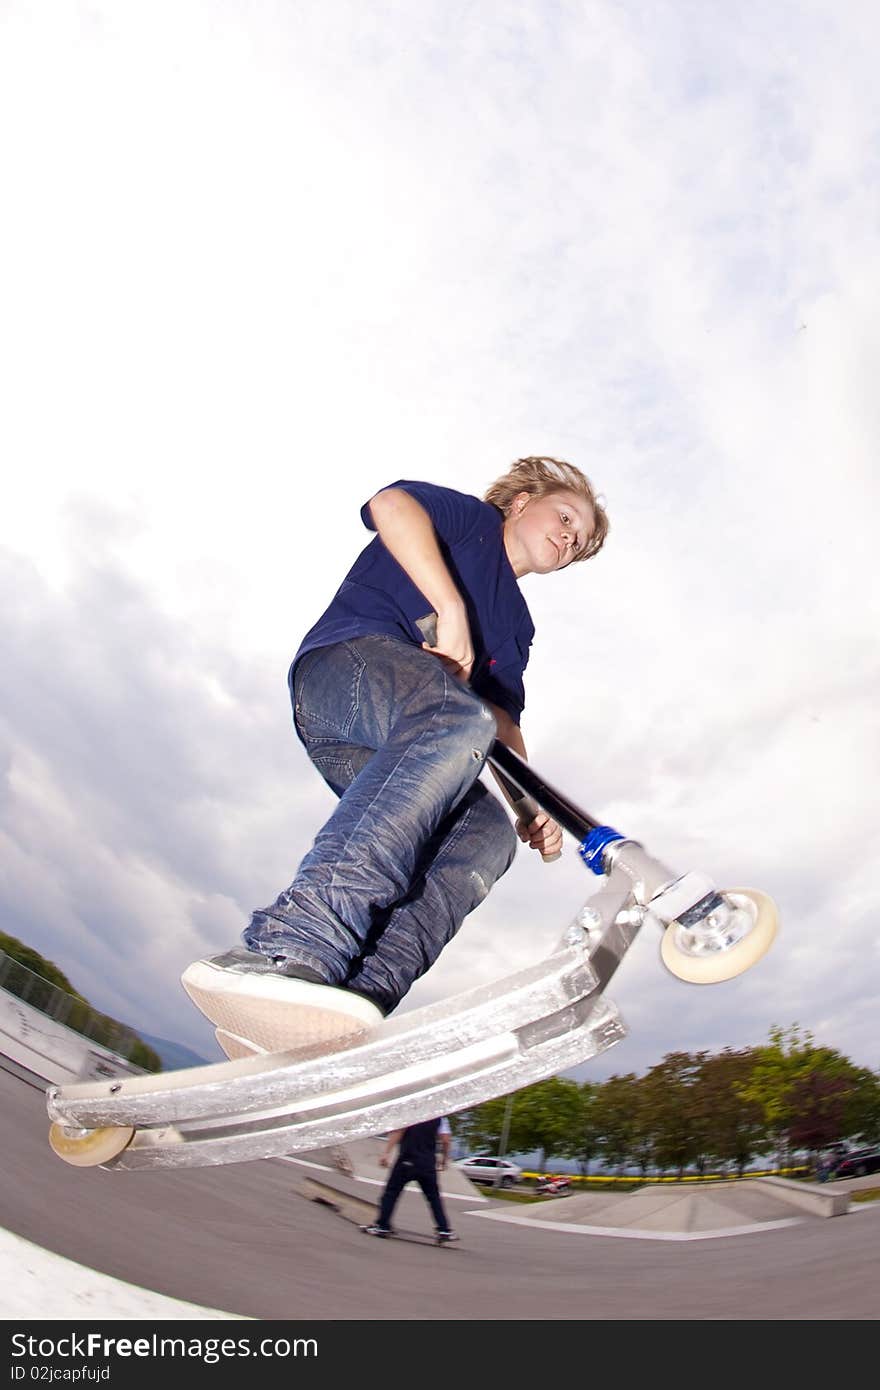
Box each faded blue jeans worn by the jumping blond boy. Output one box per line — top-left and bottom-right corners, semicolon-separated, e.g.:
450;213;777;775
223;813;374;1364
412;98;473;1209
242;635;517;1013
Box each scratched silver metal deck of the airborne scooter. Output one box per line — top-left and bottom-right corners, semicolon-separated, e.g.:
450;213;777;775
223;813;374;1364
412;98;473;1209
49;944;626;1169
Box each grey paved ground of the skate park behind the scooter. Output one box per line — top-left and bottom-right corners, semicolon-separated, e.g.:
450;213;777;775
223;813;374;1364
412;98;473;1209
0;1073;880;1321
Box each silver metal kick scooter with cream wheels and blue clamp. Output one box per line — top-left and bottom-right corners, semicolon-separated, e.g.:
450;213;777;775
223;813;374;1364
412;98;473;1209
47;742;777;1172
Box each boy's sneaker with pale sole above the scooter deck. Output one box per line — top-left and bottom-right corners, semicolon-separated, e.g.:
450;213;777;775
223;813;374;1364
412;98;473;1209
181;947;382;1056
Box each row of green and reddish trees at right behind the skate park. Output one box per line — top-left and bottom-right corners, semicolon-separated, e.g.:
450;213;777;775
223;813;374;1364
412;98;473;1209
452;1024;880;1175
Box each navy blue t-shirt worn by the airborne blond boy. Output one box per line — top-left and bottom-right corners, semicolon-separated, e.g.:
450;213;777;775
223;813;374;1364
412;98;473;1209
293;481;535;724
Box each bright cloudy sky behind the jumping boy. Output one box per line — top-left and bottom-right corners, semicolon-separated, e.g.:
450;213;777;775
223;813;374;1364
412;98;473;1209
0;0;880;1079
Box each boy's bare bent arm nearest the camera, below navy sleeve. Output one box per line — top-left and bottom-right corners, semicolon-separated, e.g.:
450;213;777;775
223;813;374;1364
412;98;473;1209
370;488;474;681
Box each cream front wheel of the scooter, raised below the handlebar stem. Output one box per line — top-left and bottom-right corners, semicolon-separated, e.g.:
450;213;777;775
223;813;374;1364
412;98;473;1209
660;888;779;984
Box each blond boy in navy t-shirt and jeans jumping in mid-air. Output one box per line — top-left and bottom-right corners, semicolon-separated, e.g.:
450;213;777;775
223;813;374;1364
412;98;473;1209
182;457;608;1056
